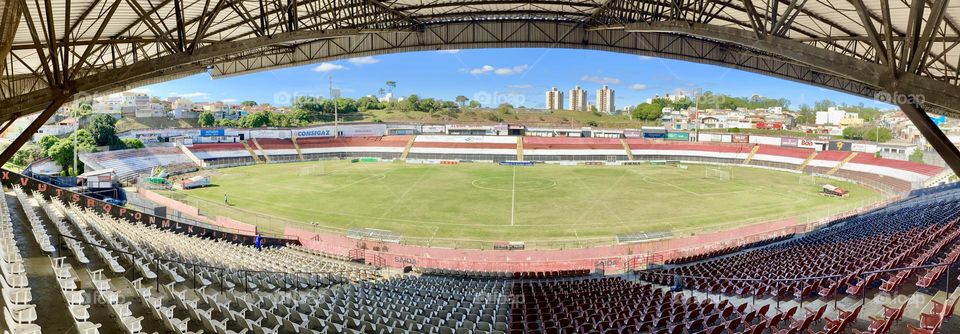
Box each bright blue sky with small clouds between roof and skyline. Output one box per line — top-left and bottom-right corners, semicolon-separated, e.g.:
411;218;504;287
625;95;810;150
137;49;892;109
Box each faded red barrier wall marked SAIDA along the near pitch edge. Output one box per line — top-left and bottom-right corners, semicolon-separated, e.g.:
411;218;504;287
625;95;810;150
284;194;897;272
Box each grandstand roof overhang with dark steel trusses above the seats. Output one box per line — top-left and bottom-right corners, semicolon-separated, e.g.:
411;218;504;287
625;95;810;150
0;0;960;169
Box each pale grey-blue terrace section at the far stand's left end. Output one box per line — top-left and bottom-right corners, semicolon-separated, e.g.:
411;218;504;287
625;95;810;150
78;147;199;181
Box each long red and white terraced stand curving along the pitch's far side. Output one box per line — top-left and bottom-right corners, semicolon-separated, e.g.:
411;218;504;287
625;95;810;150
81;135;943;195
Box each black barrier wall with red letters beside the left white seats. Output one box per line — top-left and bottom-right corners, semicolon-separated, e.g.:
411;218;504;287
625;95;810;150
0;169;300;246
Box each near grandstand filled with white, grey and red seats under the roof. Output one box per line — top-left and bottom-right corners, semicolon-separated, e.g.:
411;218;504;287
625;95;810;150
0;167;960;334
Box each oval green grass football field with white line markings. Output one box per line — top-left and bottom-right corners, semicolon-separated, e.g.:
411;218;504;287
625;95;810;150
161;161;883;244
